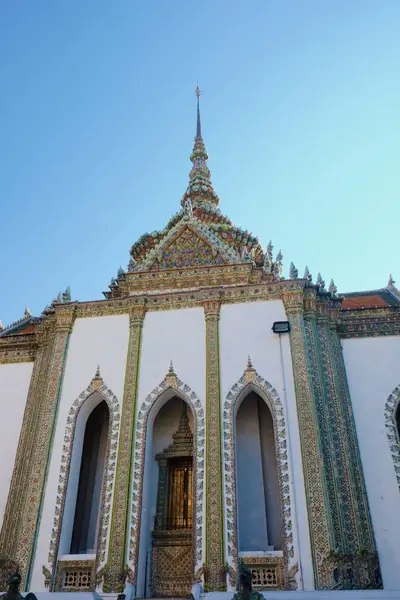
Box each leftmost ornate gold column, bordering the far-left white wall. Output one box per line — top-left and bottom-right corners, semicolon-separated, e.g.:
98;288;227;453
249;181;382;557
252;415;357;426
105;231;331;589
0;319;54;559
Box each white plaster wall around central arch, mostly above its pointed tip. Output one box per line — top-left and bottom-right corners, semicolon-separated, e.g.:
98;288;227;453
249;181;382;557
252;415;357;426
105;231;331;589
137;308;206;593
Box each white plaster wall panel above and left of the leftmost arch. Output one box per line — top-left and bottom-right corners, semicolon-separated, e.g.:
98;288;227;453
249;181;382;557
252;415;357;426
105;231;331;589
30;315;129;591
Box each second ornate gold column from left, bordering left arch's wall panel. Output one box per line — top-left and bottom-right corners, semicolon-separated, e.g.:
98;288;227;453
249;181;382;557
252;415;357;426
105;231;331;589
17;306;75;589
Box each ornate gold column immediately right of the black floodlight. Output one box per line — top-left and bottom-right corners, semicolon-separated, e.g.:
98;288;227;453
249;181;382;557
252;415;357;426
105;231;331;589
282;288;331;589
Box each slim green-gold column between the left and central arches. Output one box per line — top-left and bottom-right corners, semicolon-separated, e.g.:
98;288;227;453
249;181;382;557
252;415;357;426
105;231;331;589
103;304;145;593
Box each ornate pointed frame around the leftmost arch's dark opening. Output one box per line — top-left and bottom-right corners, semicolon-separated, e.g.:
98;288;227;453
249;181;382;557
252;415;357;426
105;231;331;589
48;370;120;575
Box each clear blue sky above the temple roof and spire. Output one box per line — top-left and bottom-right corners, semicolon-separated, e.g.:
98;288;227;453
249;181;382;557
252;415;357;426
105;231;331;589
0;0;400;325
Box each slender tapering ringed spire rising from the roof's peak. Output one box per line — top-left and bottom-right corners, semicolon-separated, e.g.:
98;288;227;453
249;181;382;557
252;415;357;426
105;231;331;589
182;86;219;206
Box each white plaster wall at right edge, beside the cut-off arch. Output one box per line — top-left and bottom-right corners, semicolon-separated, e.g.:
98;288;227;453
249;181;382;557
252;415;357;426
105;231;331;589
342;336;400;589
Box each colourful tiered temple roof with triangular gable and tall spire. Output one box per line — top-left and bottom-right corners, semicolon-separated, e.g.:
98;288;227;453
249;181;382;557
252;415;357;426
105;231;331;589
104;88;282;298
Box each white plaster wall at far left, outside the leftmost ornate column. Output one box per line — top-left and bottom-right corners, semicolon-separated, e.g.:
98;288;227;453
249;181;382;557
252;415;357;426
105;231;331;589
0;362;33;530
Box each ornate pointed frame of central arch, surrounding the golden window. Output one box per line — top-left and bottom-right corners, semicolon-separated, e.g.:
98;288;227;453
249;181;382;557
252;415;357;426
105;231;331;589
128;366;205;583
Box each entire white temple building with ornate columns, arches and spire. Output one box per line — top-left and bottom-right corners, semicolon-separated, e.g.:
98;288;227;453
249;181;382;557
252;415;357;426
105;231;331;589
0;91;400;598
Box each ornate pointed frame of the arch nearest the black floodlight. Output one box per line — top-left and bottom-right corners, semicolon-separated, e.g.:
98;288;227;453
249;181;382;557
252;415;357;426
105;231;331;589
222;359;298;589
